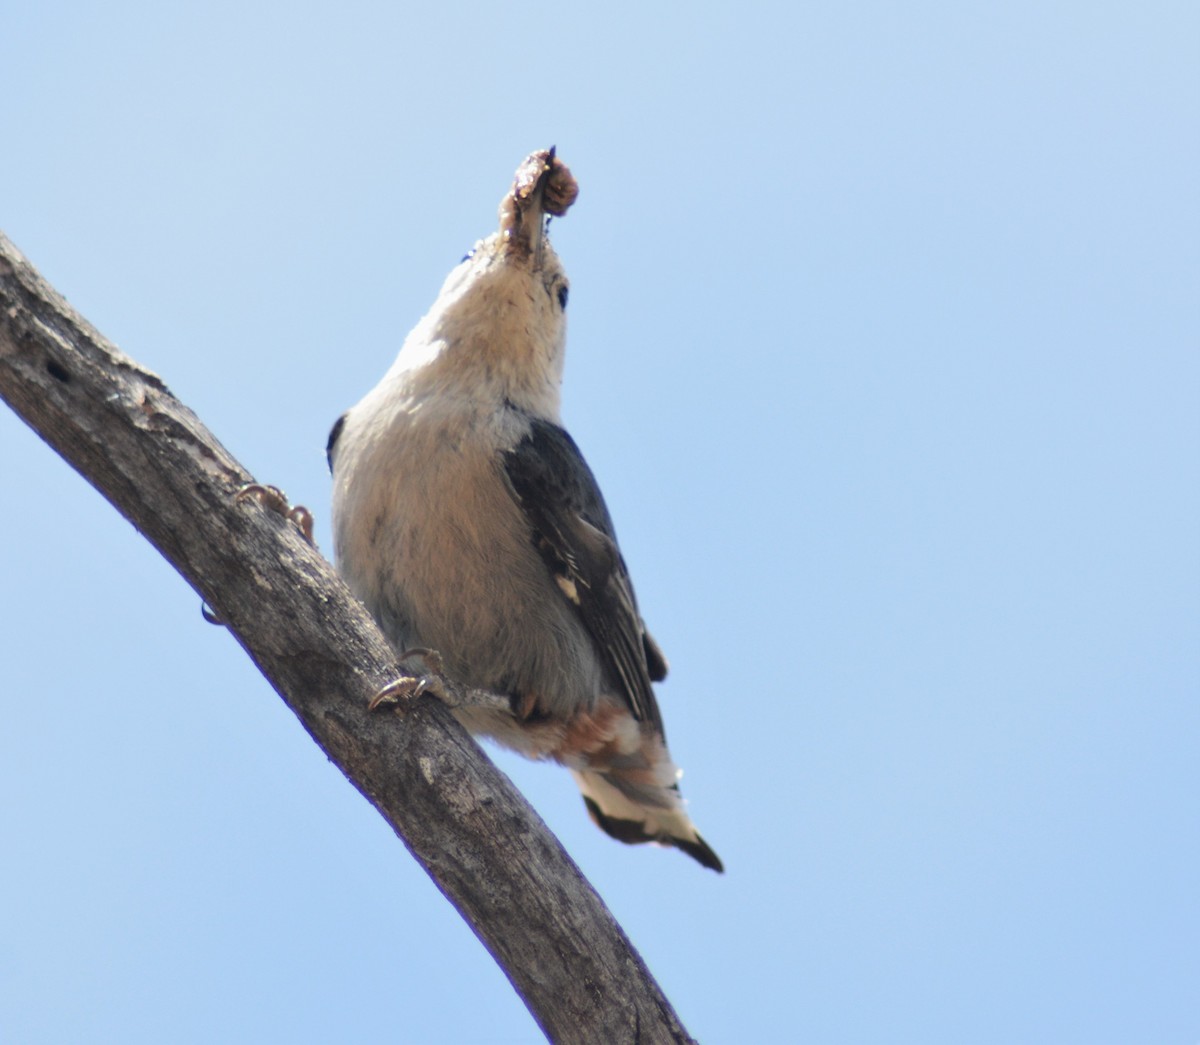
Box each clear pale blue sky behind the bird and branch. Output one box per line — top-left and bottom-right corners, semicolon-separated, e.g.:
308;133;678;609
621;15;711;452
0;0;1200;1045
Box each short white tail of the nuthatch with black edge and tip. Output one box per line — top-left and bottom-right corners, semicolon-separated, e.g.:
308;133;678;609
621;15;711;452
572;770;725;873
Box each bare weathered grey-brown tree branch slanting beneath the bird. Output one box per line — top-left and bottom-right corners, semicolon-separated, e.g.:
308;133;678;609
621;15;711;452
0;234;691;1045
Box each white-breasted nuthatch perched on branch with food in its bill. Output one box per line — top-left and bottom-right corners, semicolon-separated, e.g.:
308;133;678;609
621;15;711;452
329;149;722;871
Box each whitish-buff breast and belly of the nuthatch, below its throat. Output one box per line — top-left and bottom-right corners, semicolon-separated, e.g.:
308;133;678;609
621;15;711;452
334;382;601;729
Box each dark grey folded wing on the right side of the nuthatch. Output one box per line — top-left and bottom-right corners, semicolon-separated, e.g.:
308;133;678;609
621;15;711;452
504;418;667;733
